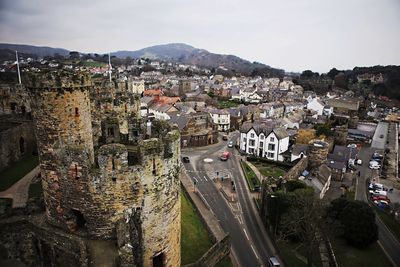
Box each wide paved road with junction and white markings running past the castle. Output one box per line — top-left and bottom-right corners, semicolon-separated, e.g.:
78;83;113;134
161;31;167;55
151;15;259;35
182;134;275;267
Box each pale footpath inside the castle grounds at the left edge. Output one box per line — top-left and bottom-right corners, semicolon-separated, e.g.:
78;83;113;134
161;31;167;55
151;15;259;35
0;165;40;208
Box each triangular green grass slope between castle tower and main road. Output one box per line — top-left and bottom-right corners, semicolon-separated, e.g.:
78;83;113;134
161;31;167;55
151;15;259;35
181;192;213;265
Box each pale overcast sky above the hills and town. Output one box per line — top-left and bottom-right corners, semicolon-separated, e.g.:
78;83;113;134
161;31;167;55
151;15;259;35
0;0;400;72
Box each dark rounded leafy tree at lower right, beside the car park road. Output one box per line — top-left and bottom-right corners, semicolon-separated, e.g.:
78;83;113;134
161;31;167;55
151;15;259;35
328;198;378;248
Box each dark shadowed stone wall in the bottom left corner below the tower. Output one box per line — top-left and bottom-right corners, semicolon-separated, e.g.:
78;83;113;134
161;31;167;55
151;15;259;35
0;215;89;267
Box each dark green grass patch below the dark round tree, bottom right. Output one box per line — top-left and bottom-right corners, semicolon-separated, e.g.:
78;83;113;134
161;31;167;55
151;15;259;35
332;238;392;267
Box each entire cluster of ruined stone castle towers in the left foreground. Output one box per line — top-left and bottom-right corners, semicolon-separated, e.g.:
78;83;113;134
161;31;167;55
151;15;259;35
2;71;181;267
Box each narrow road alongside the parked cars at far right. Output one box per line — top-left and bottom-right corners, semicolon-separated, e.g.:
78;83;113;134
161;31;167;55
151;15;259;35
356;147;400;266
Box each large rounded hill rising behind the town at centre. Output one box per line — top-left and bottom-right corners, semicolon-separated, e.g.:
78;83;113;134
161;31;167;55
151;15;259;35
112;43;283;76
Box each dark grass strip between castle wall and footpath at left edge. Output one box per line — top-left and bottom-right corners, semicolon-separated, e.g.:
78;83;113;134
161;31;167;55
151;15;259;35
0;156;39;191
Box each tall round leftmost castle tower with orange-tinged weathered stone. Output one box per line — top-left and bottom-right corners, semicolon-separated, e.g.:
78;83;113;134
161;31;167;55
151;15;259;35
28;72;94;231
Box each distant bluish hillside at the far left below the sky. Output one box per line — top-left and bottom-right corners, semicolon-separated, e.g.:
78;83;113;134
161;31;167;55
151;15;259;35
0;43;69;58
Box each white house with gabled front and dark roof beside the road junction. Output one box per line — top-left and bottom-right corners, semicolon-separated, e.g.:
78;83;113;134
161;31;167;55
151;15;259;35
239;123;289;161
